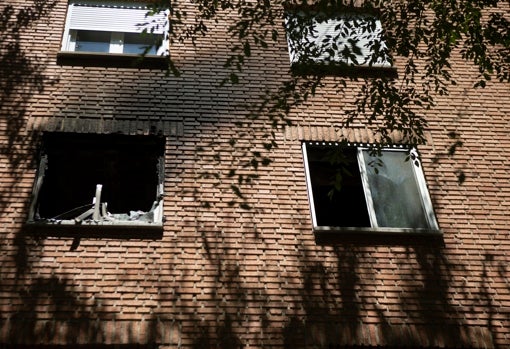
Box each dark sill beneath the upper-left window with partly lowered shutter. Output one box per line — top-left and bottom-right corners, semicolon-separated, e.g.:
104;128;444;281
57;51;168;70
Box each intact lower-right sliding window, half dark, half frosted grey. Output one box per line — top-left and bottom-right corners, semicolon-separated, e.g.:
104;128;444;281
303;143;438;231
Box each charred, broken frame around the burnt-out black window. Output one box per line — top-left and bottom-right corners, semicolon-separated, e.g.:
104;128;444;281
26;132;166;230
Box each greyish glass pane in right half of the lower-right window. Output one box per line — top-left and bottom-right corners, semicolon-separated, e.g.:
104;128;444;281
363;151;429;228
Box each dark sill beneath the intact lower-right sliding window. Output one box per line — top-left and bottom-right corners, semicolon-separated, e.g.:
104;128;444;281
313;227;443;245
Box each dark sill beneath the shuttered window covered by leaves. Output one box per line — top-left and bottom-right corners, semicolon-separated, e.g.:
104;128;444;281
291;62;398;78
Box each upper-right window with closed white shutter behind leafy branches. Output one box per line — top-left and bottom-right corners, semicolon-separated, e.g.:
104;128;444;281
286;11;392;68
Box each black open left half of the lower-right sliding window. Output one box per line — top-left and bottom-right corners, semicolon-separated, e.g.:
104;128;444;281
307;146;370;227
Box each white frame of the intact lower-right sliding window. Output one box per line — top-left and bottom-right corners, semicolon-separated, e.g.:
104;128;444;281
301;141;441;234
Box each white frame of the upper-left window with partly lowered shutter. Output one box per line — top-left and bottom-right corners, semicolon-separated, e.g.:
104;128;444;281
60;0;169;57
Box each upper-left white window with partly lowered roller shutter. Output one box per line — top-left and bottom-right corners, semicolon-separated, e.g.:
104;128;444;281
62;0;168;55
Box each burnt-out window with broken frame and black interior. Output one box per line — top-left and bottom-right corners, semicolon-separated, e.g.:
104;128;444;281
29;133;165;226
